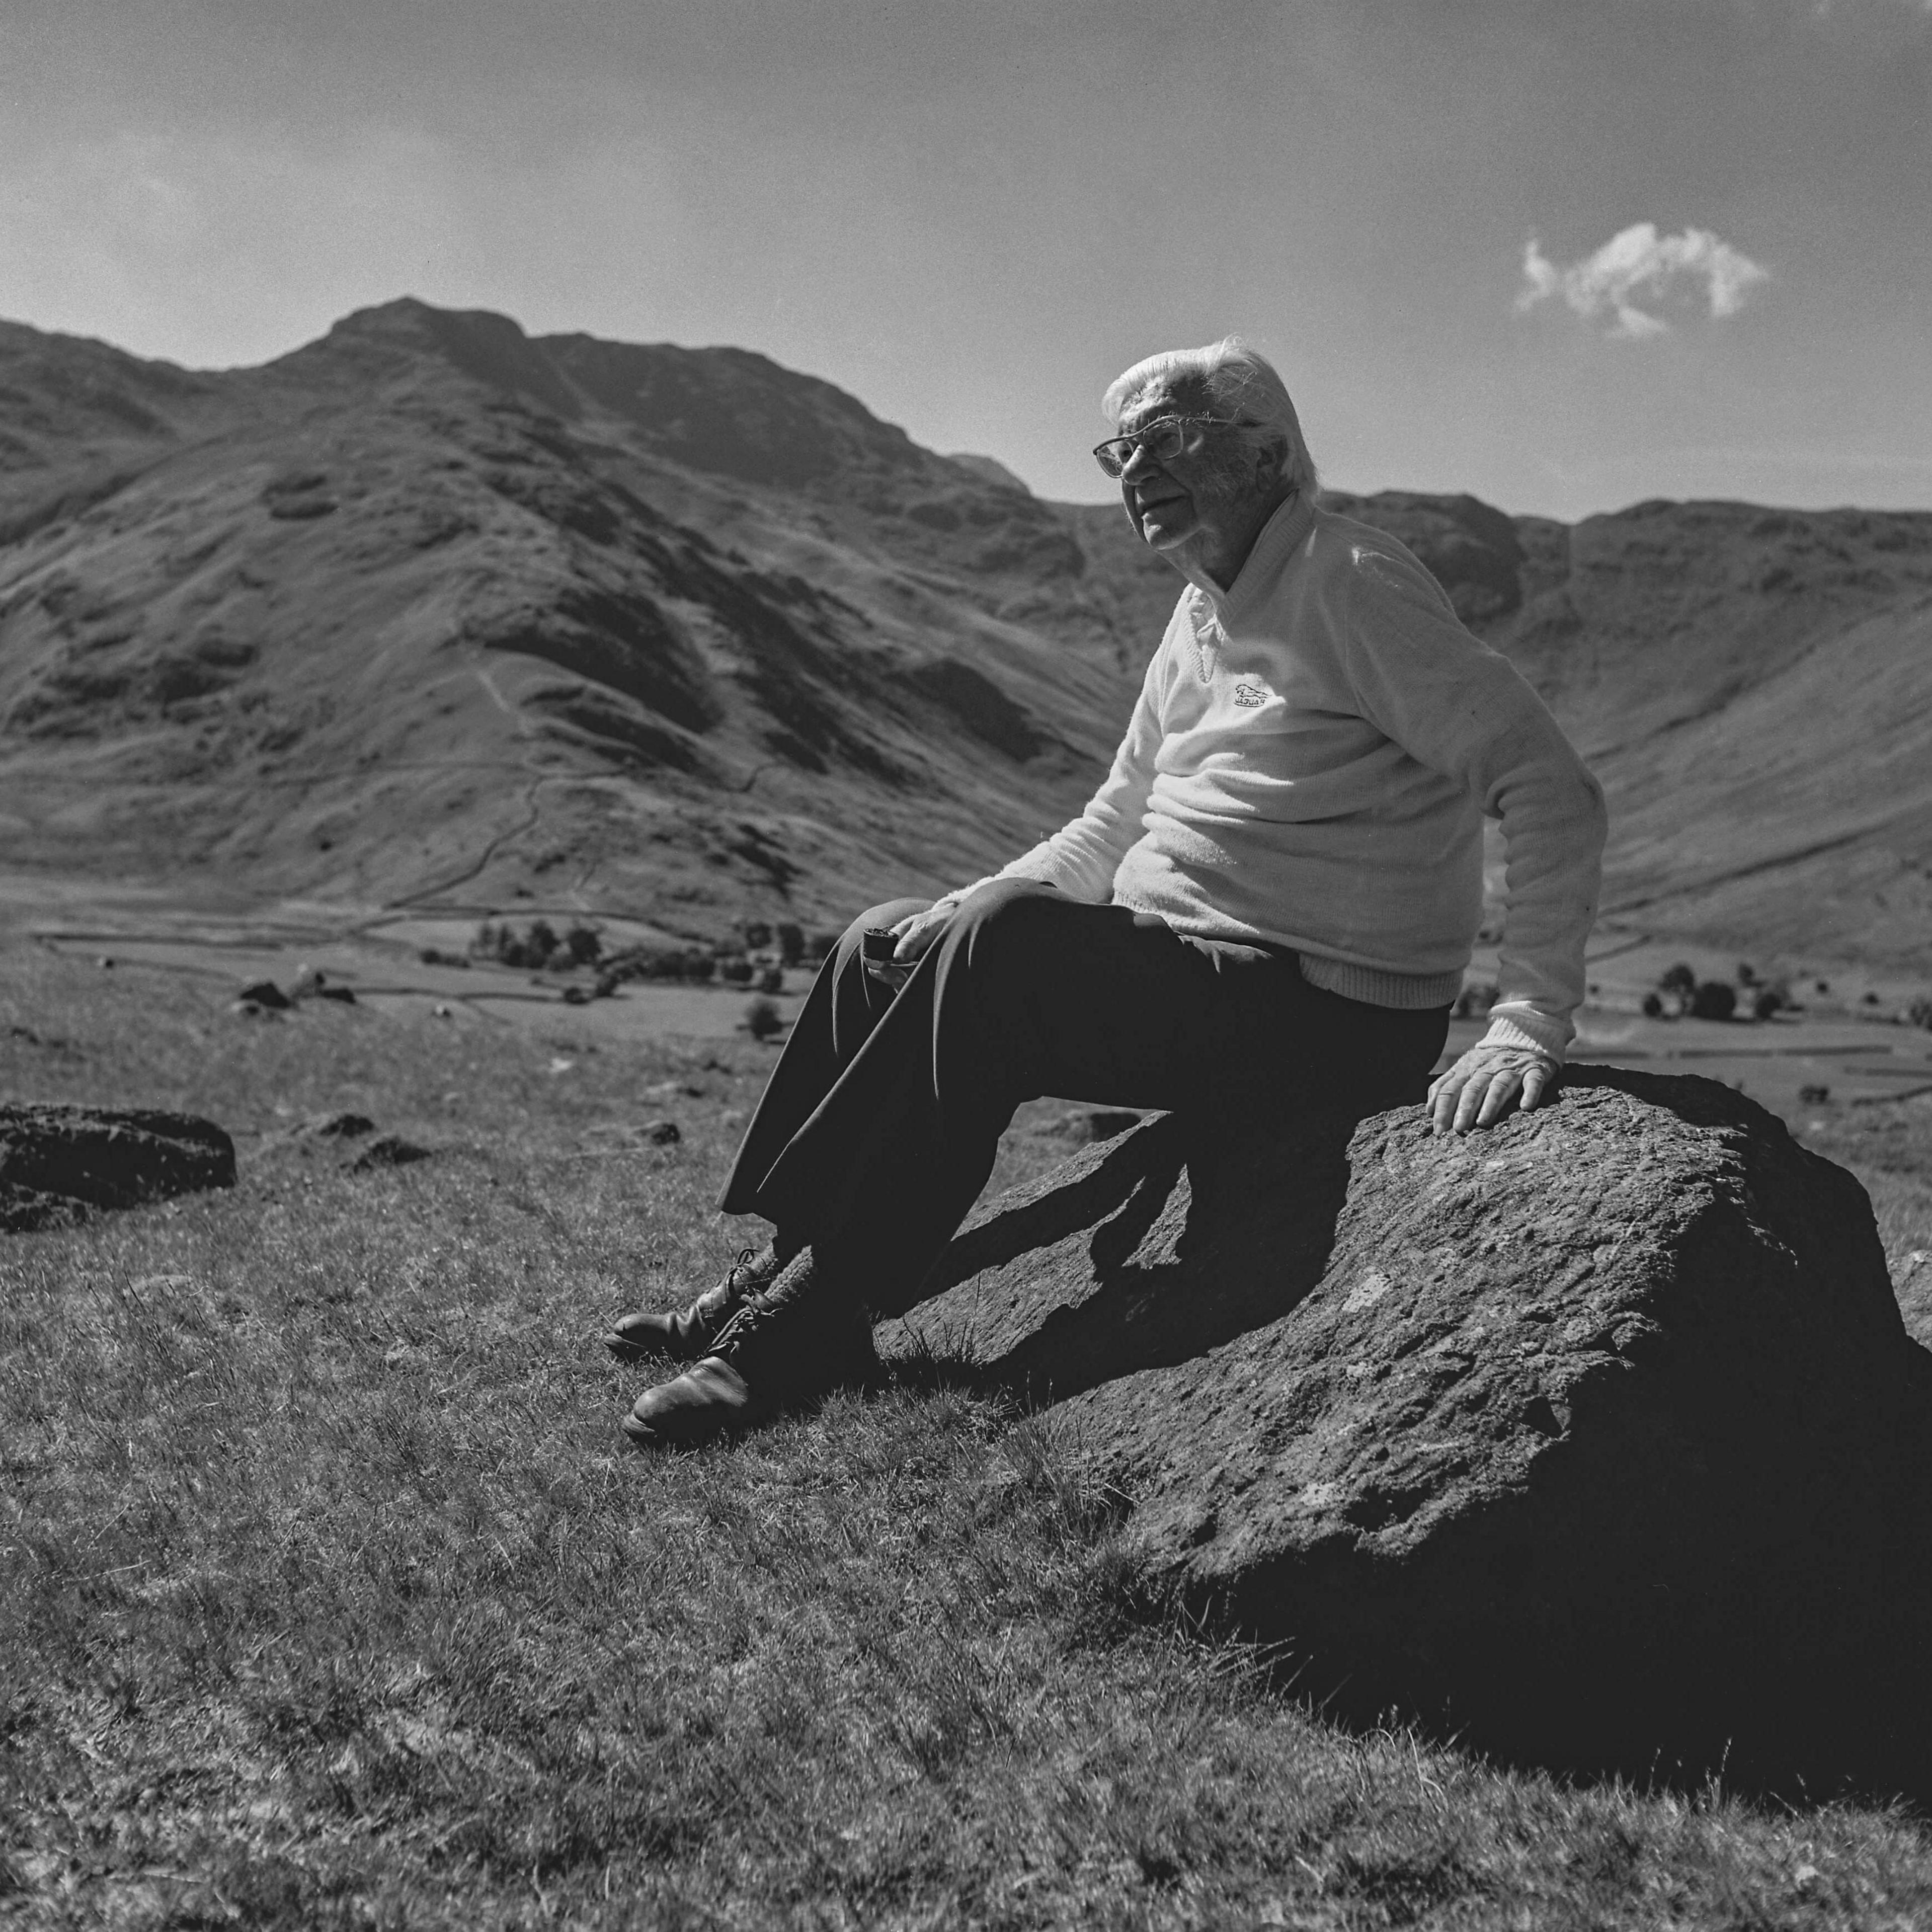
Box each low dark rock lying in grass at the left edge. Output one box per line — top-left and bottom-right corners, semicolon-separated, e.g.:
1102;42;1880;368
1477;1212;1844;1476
0;1107;235;1235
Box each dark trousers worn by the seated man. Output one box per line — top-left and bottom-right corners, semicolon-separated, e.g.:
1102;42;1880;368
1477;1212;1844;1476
718;879;1449;1318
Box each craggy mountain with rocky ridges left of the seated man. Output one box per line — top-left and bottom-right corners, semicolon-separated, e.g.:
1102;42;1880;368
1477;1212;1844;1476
0;303;1130;925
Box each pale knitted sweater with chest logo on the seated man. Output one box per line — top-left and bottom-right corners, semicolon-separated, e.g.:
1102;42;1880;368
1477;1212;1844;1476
948;487;1605;1057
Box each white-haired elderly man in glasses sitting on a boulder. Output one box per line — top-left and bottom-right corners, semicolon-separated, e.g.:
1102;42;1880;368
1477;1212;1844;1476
607;338;1603;1445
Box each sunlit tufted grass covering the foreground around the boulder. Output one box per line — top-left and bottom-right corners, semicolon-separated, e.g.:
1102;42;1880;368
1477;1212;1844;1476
0;948;1932;1928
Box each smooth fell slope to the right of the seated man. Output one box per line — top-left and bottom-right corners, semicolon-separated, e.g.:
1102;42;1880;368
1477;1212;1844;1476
1331;493;1932;966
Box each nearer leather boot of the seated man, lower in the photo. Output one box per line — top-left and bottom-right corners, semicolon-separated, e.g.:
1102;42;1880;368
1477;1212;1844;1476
624;1250;877;1449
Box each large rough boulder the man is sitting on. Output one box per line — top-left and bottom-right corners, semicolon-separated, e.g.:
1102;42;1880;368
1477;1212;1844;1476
881;1069;1932;1760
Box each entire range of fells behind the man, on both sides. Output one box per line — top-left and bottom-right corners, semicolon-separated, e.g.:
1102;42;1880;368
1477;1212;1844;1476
0;301;1932;962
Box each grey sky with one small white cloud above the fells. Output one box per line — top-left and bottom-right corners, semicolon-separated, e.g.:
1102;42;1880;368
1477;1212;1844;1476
0;0;1932;518
